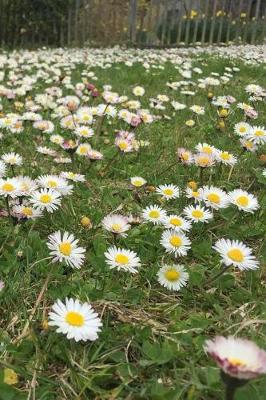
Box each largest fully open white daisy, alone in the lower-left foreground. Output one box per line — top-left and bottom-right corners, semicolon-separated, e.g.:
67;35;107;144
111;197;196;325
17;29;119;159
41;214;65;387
48;298;102;342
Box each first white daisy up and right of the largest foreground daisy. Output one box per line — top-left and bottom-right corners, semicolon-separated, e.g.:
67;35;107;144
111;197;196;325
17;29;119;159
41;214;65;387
104;246;141;274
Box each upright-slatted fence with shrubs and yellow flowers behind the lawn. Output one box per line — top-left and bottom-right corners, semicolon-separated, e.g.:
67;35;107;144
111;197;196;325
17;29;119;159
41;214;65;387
0;0;266;48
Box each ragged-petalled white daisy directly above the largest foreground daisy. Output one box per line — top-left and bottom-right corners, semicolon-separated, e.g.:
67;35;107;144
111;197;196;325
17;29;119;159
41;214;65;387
47;231;86;269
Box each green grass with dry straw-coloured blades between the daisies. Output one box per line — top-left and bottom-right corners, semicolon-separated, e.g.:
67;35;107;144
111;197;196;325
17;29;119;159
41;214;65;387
0;50;266;400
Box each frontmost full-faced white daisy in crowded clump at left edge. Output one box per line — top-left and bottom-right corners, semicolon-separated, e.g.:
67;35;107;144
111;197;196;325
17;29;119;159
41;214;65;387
29;189;61;213
